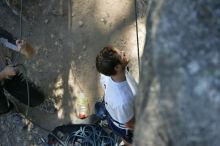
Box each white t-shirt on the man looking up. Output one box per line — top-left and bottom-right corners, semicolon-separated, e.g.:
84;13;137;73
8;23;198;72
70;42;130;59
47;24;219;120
100;71;137;126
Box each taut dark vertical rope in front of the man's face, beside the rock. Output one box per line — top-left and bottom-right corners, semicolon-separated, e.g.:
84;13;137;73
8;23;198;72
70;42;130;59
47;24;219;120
134;0;141;78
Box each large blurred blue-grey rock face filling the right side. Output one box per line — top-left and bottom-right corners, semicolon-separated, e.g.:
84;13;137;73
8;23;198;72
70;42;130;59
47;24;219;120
134;0;220;146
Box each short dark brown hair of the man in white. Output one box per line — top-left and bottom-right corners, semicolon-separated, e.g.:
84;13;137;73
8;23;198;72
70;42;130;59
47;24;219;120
96;46;120;76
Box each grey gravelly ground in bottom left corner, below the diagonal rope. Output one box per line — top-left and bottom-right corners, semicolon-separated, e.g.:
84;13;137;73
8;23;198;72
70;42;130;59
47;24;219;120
0;113;48;146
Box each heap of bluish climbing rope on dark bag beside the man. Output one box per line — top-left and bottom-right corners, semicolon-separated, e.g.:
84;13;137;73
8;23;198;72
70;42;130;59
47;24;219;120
49;124;119;146
